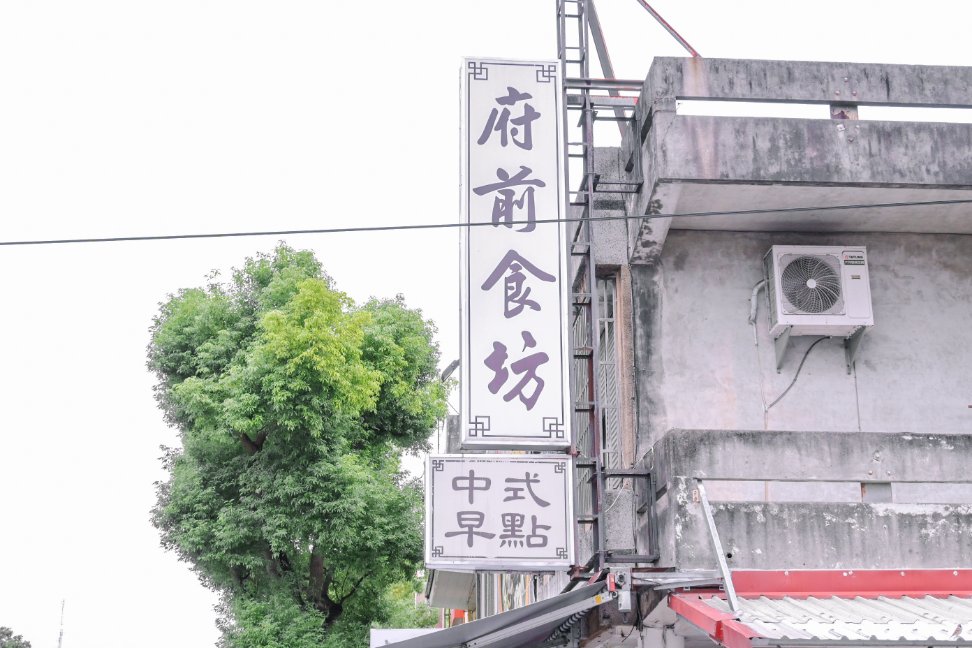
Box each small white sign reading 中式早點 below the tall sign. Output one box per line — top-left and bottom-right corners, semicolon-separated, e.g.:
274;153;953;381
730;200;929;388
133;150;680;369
425;454;574;571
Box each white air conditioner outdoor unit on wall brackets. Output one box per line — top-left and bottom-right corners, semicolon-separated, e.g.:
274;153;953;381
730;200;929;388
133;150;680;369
763;245;874;370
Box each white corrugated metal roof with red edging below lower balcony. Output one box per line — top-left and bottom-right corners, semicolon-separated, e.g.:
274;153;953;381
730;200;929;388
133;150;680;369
704;596;972;642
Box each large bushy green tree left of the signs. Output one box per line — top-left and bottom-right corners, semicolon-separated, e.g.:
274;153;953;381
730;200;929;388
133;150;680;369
148;245;445;648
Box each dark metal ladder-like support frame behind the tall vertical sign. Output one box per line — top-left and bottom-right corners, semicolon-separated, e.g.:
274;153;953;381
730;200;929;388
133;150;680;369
556;0;698;587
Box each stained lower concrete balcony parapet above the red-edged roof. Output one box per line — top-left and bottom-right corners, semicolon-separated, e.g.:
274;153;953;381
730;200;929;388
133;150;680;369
641;430;972;569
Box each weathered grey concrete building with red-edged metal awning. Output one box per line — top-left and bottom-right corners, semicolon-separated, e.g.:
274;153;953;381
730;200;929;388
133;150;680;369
404;58;972;648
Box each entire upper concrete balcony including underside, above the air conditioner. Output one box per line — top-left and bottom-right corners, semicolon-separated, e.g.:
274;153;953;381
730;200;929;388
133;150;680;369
621;58;972;263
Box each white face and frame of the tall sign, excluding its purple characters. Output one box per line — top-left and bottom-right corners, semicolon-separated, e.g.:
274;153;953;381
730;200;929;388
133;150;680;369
459;58;572;451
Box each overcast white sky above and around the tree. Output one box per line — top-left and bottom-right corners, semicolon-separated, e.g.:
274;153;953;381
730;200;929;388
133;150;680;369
0;0;972;648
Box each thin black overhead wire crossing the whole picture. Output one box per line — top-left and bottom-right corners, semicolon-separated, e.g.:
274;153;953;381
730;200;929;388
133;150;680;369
0;198;972;247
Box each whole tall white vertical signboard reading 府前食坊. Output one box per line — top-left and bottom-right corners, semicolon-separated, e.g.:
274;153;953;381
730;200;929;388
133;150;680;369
460;59;571;450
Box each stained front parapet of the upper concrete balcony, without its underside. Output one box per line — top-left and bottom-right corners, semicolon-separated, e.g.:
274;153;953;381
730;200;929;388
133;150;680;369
623;58;972;192
